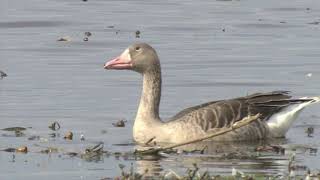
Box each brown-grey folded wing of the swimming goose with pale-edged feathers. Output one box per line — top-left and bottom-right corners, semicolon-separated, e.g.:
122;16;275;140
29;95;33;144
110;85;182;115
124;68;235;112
170;91;312;131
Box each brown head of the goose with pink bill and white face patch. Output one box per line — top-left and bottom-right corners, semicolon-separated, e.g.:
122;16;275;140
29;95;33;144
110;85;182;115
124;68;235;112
104;43;160;74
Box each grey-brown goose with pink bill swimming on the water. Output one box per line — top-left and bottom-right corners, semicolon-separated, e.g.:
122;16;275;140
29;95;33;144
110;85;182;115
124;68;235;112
104;43;320;144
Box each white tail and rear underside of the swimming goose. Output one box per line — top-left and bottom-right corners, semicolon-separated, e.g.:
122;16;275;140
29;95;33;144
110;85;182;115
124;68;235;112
267;97;320;137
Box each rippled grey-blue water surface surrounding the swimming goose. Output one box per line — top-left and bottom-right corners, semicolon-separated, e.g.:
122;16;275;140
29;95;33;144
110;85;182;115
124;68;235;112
0;0;320;179
